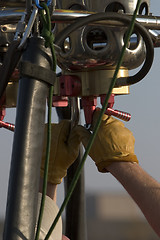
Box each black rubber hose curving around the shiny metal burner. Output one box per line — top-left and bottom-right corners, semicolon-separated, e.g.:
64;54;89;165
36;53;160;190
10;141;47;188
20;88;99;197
55;13;154;87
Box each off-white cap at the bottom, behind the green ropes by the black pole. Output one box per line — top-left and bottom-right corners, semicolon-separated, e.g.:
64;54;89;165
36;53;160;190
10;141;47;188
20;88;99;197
37;193;62;240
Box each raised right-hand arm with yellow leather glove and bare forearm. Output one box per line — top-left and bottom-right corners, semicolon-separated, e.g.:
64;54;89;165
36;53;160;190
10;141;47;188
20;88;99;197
77;110;160;236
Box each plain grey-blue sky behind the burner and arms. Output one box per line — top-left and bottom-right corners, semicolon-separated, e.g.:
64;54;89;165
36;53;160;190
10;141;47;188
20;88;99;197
0;0;160;218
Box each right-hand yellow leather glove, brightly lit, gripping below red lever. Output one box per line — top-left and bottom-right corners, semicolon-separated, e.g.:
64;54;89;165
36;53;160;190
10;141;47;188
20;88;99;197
76;109;138;172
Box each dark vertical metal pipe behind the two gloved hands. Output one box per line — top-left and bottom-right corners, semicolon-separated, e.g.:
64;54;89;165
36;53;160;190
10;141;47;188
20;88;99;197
65;98;87;240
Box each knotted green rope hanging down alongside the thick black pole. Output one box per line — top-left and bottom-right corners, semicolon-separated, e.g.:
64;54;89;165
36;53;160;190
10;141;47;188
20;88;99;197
35;3;56;240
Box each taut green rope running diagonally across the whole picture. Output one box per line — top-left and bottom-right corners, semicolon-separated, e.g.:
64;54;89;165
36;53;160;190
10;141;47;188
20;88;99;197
44;0;141;240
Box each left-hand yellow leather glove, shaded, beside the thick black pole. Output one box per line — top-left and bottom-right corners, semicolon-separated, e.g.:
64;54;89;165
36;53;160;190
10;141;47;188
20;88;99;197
41;120;80;184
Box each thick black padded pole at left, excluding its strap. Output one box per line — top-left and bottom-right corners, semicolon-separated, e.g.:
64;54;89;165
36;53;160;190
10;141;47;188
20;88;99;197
3;38;51;240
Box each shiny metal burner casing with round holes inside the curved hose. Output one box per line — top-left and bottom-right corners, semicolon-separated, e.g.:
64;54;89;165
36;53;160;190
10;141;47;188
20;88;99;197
56;0;149;72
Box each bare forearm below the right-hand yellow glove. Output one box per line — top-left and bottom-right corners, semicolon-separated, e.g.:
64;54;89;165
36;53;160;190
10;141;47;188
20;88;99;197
107;162;160;237
